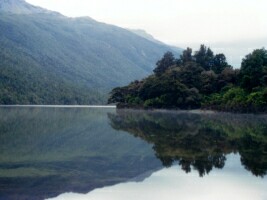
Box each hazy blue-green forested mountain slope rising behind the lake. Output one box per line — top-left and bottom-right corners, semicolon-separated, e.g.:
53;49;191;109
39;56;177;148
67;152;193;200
0;0;180;104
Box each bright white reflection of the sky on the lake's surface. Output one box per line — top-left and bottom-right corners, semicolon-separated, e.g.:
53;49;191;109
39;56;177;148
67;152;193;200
49;154;267;200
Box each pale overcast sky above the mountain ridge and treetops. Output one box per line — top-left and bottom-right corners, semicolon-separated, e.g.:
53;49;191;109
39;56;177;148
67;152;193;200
26;0;267;67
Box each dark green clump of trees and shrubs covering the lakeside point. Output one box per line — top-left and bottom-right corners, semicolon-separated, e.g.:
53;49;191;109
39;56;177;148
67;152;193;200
109;45;267;112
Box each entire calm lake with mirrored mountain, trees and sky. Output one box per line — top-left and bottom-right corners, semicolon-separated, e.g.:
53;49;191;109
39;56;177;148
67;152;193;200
0;106;267;200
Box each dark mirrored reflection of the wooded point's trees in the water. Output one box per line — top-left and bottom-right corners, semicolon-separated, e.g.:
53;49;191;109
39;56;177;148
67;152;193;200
108;110;267;177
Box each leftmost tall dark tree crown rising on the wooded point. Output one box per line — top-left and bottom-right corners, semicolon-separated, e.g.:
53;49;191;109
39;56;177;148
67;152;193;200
153;51;176;76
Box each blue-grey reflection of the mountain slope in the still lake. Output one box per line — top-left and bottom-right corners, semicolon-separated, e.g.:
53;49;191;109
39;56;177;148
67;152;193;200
0;108;161;200
